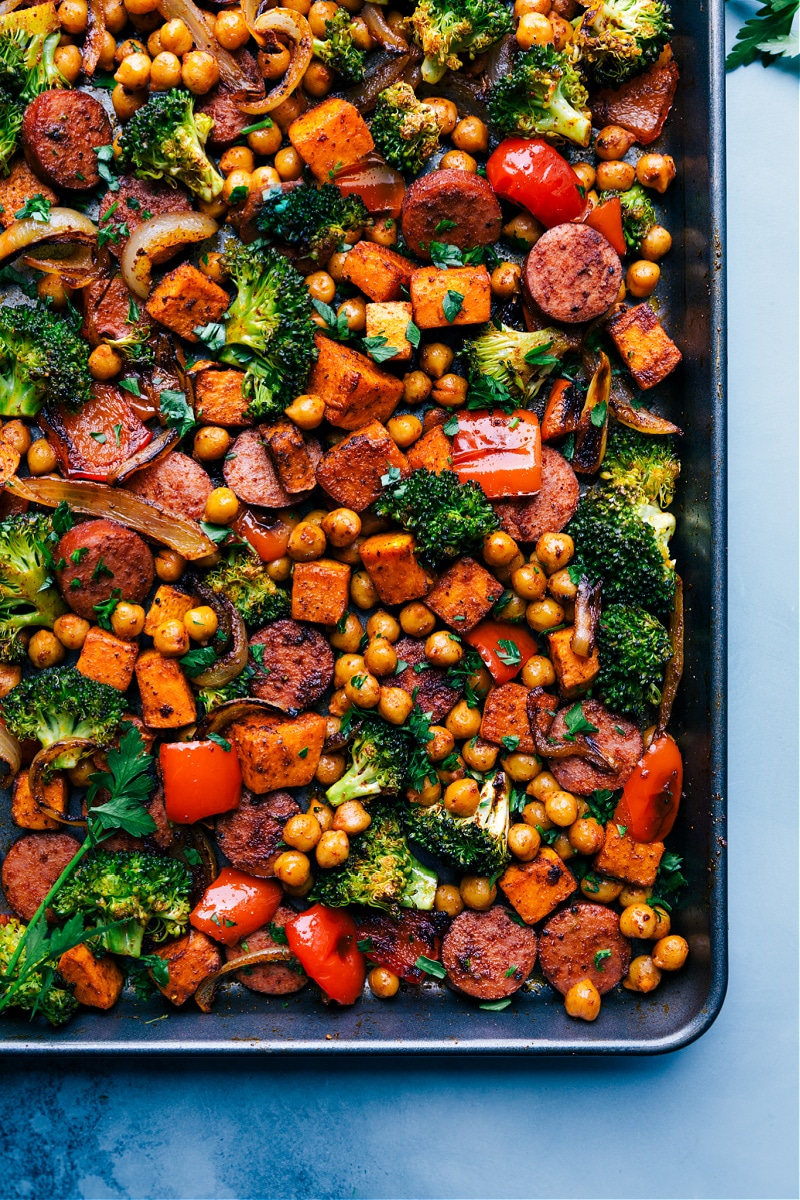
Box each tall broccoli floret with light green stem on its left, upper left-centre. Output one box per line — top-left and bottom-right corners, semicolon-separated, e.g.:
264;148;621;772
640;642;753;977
219;240;317;421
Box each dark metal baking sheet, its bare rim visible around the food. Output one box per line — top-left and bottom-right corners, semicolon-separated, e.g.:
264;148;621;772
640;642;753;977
0;0;727;1055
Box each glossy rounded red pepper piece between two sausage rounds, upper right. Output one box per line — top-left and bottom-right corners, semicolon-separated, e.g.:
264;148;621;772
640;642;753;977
486;138;588;229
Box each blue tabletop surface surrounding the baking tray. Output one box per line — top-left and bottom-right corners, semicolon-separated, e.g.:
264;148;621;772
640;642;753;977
0;11;799;1200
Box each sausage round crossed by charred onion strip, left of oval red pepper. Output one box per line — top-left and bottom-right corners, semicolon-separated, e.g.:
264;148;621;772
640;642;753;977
549;700;644;796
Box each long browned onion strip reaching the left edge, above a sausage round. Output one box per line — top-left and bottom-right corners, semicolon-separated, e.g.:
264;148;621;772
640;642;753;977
6;475;216;559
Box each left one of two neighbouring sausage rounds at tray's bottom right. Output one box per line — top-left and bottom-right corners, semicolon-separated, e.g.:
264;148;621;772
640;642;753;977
441;905;536;1000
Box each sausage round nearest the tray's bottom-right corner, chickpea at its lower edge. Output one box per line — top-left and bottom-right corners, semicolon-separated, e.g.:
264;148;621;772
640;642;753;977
539;904;631;996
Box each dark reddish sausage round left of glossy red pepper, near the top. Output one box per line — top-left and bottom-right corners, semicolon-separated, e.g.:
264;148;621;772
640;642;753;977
401;170;503;260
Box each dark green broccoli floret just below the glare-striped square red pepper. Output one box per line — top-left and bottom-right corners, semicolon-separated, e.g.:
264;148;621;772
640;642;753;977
375;468;500;565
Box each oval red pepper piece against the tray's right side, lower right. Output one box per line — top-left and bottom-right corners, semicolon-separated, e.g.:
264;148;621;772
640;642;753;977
614;733;684;841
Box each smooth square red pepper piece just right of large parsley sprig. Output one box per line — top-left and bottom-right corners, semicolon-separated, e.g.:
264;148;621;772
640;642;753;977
160;742;241;824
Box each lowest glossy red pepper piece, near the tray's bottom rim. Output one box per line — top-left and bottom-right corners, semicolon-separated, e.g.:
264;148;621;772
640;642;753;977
284;904;367;1004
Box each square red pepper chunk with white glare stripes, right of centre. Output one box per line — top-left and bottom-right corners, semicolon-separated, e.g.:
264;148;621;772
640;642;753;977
452;409;542;500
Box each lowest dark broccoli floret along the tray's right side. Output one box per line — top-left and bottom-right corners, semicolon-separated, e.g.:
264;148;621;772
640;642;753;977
596;604;672;725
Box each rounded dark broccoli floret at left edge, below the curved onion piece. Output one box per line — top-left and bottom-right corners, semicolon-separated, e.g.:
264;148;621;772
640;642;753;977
0;305;91;416
